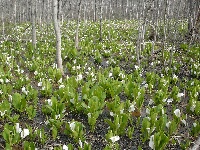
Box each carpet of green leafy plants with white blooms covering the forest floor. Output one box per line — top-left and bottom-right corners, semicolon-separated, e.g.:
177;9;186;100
0;21;200;150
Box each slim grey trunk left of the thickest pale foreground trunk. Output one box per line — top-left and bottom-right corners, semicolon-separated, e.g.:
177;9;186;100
31;0;36;50
